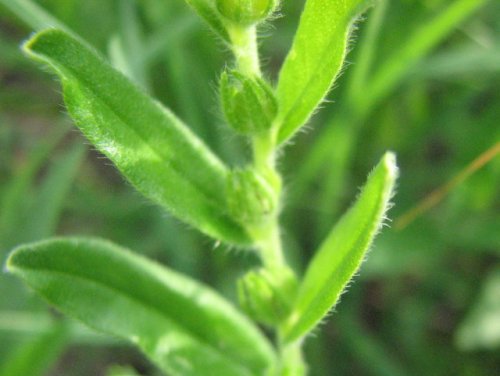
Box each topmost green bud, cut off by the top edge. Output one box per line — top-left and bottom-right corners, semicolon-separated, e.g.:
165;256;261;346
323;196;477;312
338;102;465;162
216;0;278;26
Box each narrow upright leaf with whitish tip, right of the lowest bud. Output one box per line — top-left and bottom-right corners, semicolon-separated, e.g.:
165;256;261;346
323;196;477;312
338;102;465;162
282;153;397;342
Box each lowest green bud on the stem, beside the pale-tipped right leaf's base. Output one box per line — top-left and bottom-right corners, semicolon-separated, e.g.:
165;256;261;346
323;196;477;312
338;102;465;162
238;267;298;326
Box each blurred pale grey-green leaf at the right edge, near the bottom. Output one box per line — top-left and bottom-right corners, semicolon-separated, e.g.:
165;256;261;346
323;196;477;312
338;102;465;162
455;267;500;351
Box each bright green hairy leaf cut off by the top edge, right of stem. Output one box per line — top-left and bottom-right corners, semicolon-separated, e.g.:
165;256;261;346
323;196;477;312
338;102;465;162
278;0;366;142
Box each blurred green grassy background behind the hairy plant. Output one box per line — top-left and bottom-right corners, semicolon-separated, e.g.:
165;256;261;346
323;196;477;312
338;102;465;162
0;0;500;376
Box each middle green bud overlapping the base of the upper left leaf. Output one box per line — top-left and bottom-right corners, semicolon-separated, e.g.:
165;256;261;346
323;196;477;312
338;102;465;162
226;168;278;224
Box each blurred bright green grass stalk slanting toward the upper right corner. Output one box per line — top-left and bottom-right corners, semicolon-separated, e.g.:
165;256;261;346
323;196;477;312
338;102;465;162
290;0;487;239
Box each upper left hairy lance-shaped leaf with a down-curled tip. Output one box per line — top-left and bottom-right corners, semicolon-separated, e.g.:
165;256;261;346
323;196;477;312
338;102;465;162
24;29;248;244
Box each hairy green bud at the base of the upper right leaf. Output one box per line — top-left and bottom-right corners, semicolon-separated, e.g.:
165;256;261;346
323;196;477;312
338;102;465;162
220;71;278;135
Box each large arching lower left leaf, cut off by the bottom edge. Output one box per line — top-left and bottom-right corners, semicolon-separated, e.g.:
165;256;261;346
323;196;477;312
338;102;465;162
7;239;274;376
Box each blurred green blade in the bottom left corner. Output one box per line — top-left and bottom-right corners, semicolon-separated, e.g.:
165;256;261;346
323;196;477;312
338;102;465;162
0;323;68;376
